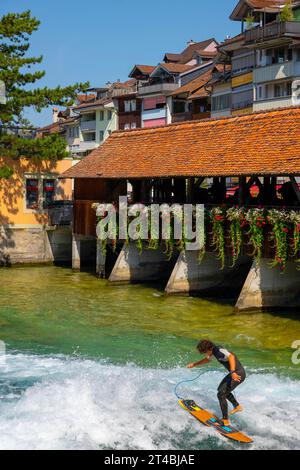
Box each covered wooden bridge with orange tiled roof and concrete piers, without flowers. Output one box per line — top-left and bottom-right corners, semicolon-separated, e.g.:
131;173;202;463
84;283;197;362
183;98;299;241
62;107;300;310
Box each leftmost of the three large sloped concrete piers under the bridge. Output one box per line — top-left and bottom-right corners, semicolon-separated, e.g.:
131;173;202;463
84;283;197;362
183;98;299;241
109;242;175;282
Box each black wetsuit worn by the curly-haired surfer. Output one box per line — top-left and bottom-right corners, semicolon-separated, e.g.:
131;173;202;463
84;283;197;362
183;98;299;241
209;346;246;420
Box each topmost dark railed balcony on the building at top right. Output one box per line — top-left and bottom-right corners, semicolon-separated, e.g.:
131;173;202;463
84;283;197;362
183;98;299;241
245;21;300;46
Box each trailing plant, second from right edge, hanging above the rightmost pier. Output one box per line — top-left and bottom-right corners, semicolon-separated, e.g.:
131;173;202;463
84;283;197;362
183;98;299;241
268;209;291;272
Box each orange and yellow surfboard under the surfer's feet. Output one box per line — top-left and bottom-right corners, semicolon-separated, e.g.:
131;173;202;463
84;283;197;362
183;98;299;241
179;400;253;444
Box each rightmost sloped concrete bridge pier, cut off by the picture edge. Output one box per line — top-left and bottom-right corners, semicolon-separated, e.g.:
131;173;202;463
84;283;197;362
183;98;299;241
236;259;300;311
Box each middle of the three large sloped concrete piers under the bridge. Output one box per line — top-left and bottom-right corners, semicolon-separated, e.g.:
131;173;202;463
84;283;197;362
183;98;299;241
166;251;251;297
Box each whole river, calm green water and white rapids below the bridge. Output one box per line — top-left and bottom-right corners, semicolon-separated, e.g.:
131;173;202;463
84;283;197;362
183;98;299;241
0;267;300;450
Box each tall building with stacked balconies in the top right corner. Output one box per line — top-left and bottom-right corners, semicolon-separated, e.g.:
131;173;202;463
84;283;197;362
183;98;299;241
212;0;300;116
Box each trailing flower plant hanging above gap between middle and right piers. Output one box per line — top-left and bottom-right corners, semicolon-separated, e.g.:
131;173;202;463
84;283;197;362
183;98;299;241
226;207;247;267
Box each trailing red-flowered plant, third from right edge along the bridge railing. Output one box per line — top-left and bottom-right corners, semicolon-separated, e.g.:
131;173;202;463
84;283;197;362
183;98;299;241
245;209;266;263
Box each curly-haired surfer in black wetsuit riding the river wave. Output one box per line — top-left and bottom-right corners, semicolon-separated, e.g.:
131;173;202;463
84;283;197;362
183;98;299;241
188;340;246;426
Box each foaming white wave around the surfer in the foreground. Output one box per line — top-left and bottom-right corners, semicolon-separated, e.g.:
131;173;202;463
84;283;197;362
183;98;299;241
0;354;300;450
